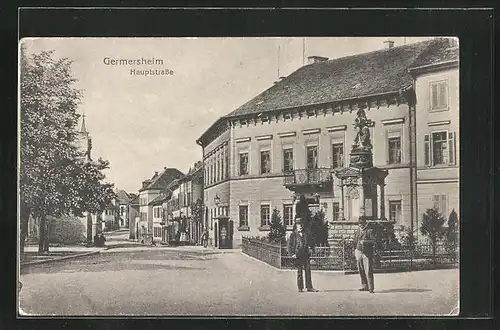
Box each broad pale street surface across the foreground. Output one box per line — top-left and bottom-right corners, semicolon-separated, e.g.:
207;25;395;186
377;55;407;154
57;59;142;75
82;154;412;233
20;248;458;316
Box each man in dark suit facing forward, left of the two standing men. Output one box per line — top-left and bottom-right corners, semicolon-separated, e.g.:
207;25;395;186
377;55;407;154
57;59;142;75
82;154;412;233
288;217;318;292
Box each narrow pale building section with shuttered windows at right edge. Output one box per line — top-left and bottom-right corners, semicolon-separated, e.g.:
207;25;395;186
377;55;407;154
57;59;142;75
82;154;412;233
410;41;460;237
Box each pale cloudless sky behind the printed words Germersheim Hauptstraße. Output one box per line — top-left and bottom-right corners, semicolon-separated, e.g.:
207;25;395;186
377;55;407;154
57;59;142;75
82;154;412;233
22;37;430;193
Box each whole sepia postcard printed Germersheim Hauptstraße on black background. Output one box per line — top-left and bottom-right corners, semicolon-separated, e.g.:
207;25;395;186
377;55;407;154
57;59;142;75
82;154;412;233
18;36;460;317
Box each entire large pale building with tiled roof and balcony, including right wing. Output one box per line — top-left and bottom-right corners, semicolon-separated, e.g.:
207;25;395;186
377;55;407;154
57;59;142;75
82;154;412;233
197;38;459;247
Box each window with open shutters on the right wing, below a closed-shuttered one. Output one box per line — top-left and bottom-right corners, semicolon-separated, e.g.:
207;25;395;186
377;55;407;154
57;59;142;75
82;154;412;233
424;131;456;166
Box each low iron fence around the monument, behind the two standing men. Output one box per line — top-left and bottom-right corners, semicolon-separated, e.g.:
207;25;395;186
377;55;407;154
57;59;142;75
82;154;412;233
242;237;459;272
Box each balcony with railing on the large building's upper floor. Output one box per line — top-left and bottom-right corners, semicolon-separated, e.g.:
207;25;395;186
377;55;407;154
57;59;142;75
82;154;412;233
284;168;333;191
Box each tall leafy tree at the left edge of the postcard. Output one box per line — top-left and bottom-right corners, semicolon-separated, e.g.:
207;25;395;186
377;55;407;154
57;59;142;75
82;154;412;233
20;45;115;252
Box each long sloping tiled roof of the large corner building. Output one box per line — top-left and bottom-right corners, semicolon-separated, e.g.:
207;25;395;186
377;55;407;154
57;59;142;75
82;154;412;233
225;38;455;118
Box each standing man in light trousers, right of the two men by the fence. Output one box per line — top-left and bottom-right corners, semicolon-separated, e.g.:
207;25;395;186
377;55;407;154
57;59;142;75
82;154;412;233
354;217;375;293
